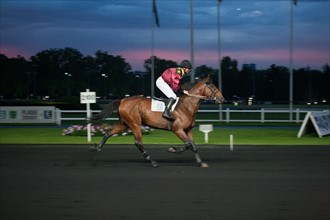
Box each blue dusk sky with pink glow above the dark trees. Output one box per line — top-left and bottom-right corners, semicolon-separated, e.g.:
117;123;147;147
0;0;330;71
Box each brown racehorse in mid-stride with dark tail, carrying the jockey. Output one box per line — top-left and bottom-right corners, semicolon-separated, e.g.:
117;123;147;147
90;76;224;167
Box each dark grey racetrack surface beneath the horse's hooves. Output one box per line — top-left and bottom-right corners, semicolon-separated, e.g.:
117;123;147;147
0;145;330;220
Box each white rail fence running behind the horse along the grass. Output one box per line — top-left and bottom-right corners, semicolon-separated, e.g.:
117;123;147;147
56;108;310;125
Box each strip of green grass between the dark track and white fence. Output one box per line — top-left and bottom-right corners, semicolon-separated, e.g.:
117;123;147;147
0;126;330;146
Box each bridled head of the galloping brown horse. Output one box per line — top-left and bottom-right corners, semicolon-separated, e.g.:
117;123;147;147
196;76;225;104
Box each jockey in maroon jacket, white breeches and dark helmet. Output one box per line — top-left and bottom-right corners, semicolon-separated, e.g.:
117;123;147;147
156;60;191;120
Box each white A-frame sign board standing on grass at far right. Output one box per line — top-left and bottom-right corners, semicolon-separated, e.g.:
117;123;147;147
298;111;330;138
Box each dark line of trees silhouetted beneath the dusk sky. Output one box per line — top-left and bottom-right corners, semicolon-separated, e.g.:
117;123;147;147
0;48;330;103
